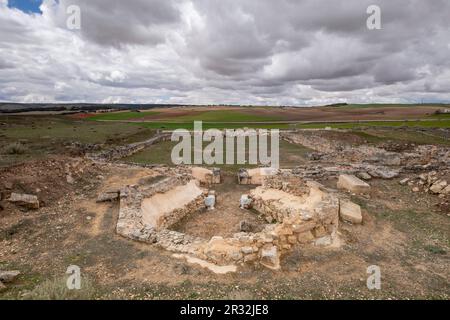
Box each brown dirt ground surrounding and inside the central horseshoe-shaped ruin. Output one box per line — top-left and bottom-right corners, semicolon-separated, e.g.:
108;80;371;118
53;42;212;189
0;151;450;299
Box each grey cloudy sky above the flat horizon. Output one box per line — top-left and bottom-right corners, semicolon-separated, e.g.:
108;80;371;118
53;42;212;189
0;0;450;105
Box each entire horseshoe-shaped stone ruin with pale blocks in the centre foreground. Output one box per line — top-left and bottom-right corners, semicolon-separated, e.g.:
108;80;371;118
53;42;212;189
112;168;339;272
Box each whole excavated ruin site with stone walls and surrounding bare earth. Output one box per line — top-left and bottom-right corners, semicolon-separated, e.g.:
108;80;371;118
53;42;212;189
0;116;450;299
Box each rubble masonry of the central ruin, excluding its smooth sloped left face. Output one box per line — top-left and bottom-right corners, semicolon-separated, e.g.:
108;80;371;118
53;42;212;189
117;171;339;269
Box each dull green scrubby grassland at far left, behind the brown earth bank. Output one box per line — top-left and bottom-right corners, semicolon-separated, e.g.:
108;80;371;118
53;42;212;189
0;116;155;166
